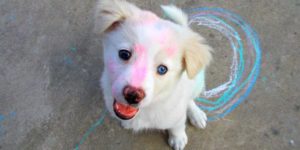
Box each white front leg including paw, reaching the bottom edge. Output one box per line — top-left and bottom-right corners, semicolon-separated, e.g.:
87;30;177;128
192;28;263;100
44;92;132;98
168;119;188;150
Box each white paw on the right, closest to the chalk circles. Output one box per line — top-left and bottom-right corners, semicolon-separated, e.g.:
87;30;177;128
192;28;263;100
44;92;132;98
187;101;207;128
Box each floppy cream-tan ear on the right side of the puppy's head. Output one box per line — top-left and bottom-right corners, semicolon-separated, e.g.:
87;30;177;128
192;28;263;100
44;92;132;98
183;31;212;79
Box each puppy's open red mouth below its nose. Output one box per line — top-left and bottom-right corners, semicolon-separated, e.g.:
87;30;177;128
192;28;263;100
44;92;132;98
113;100;139;120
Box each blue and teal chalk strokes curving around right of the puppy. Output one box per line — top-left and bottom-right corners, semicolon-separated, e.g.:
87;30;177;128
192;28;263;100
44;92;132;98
188;8;261;121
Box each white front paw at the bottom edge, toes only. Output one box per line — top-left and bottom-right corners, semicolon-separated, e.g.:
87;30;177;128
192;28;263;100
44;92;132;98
169;132;188;150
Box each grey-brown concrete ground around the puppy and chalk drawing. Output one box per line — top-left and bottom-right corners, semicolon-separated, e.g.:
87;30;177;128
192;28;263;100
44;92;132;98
0;0;300;150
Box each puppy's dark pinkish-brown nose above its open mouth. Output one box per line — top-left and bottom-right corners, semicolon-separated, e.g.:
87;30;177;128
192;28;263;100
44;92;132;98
123;85;145;104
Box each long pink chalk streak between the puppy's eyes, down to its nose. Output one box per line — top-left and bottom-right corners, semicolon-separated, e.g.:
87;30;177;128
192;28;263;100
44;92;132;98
130;44;147;87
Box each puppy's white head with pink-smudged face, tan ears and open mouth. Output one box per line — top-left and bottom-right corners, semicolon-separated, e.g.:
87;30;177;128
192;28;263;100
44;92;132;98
96;0;211;119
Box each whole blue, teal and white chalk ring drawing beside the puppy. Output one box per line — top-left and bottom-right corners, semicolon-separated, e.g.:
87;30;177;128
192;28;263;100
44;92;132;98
188;8;261;121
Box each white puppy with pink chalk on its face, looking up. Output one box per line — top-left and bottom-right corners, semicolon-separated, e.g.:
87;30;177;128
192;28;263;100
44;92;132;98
95;0;212;150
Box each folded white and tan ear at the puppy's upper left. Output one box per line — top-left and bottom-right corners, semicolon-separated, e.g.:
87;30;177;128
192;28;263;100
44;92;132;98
94;0;139;34
